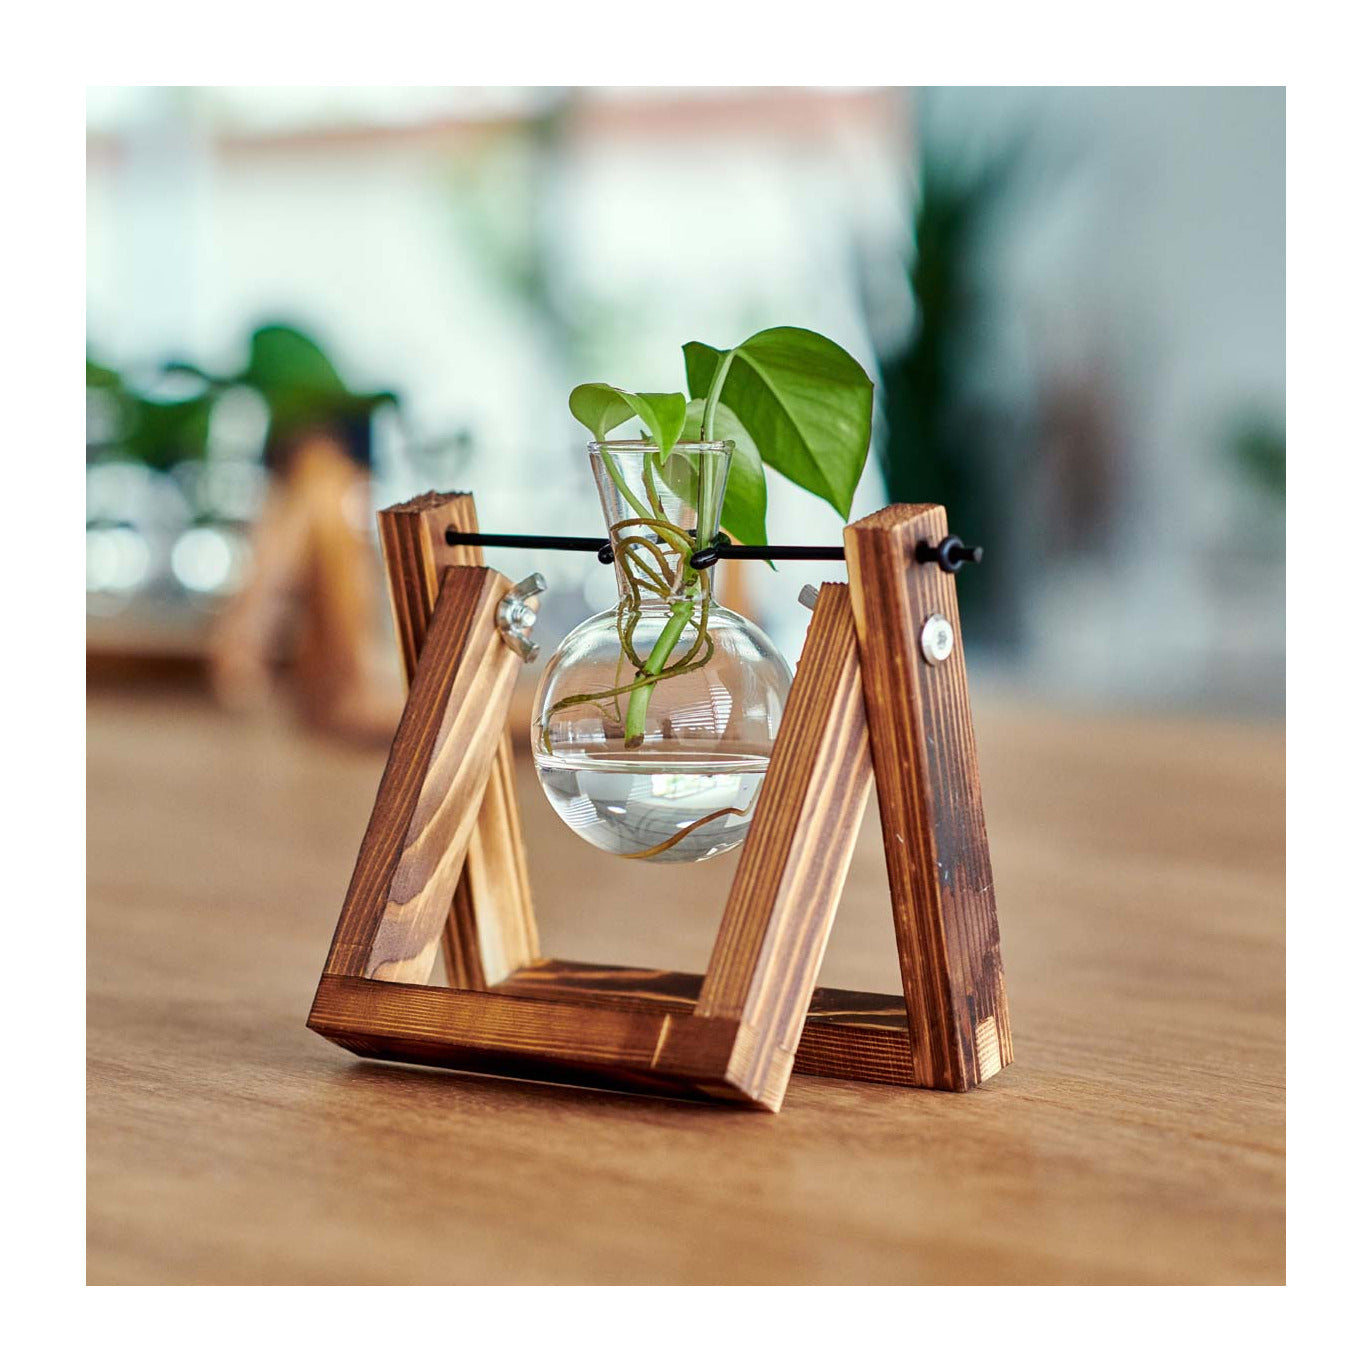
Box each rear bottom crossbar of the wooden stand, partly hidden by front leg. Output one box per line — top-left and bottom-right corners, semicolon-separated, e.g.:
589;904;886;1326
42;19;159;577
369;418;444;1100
495;958;914;1085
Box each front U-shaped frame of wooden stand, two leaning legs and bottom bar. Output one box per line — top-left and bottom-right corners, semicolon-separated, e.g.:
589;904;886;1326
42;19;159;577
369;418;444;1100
309;568;878;1111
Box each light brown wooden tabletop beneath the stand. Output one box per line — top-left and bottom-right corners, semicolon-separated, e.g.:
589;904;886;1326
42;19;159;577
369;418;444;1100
88;694;1286;1284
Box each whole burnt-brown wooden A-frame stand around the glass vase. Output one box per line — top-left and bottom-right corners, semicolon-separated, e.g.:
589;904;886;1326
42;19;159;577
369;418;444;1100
309;494;1011;1110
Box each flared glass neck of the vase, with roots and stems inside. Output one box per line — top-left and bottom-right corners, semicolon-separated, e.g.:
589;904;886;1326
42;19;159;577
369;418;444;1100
589;442;734;601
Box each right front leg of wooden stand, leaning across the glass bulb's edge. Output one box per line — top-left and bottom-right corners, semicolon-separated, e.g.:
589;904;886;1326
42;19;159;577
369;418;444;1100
696;583;871;1110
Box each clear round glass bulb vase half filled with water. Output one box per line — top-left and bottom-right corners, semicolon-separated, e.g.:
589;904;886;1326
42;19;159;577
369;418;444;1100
531;442;790;862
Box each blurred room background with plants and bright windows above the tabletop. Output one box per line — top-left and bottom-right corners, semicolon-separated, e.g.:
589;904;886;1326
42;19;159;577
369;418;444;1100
86;86;1286;734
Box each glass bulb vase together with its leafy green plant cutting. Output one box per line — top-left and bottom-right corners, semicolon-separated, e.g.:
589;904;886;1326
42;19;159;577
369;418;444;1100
534;328;873;860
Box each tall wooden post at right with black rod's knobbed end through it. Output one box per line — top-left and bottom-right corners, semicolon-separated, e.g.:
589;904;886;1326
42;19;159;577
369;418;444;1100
844;505;1013;1091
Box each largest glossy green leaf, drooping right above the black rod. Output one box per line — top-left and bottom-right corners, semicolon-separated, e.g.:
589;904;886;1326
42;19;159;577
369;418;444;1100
682;328;873;519
